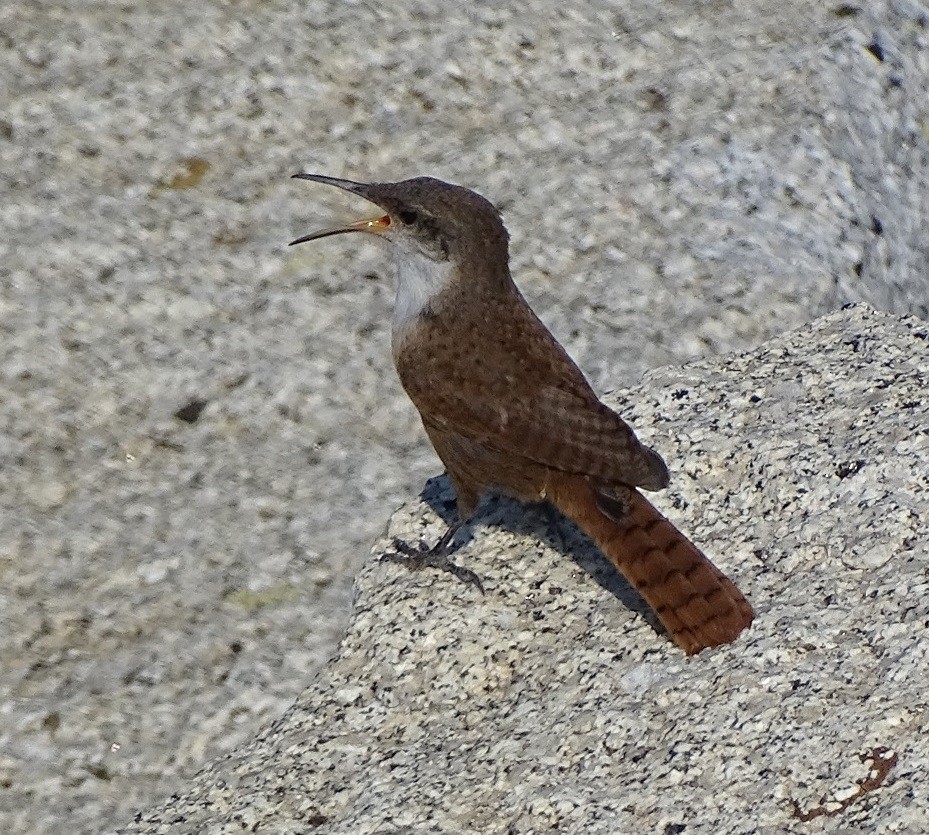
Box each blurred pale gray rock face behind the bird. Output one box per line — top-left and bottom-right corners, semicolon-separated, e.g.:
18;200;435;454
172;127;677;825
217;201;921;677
0;0;929;835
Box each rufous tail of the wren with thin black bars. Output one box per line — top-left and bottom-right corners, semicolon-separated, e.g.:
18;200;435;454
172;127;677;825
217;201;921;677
547;476;754;655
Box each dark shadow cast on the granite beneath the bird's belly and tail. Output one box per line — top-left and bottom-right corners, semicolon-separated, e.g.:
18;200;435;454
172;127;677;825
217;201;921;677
420;475;664;634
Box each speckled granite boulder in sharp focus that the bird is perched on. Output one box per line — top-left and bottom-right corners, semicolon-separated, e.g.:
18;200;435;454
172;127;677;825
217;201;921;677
125;305;929;835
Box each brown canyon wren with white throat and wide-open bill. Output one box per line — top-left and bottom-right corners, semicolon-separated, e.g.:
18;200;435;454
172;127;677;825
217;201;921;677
292;174;754;655
